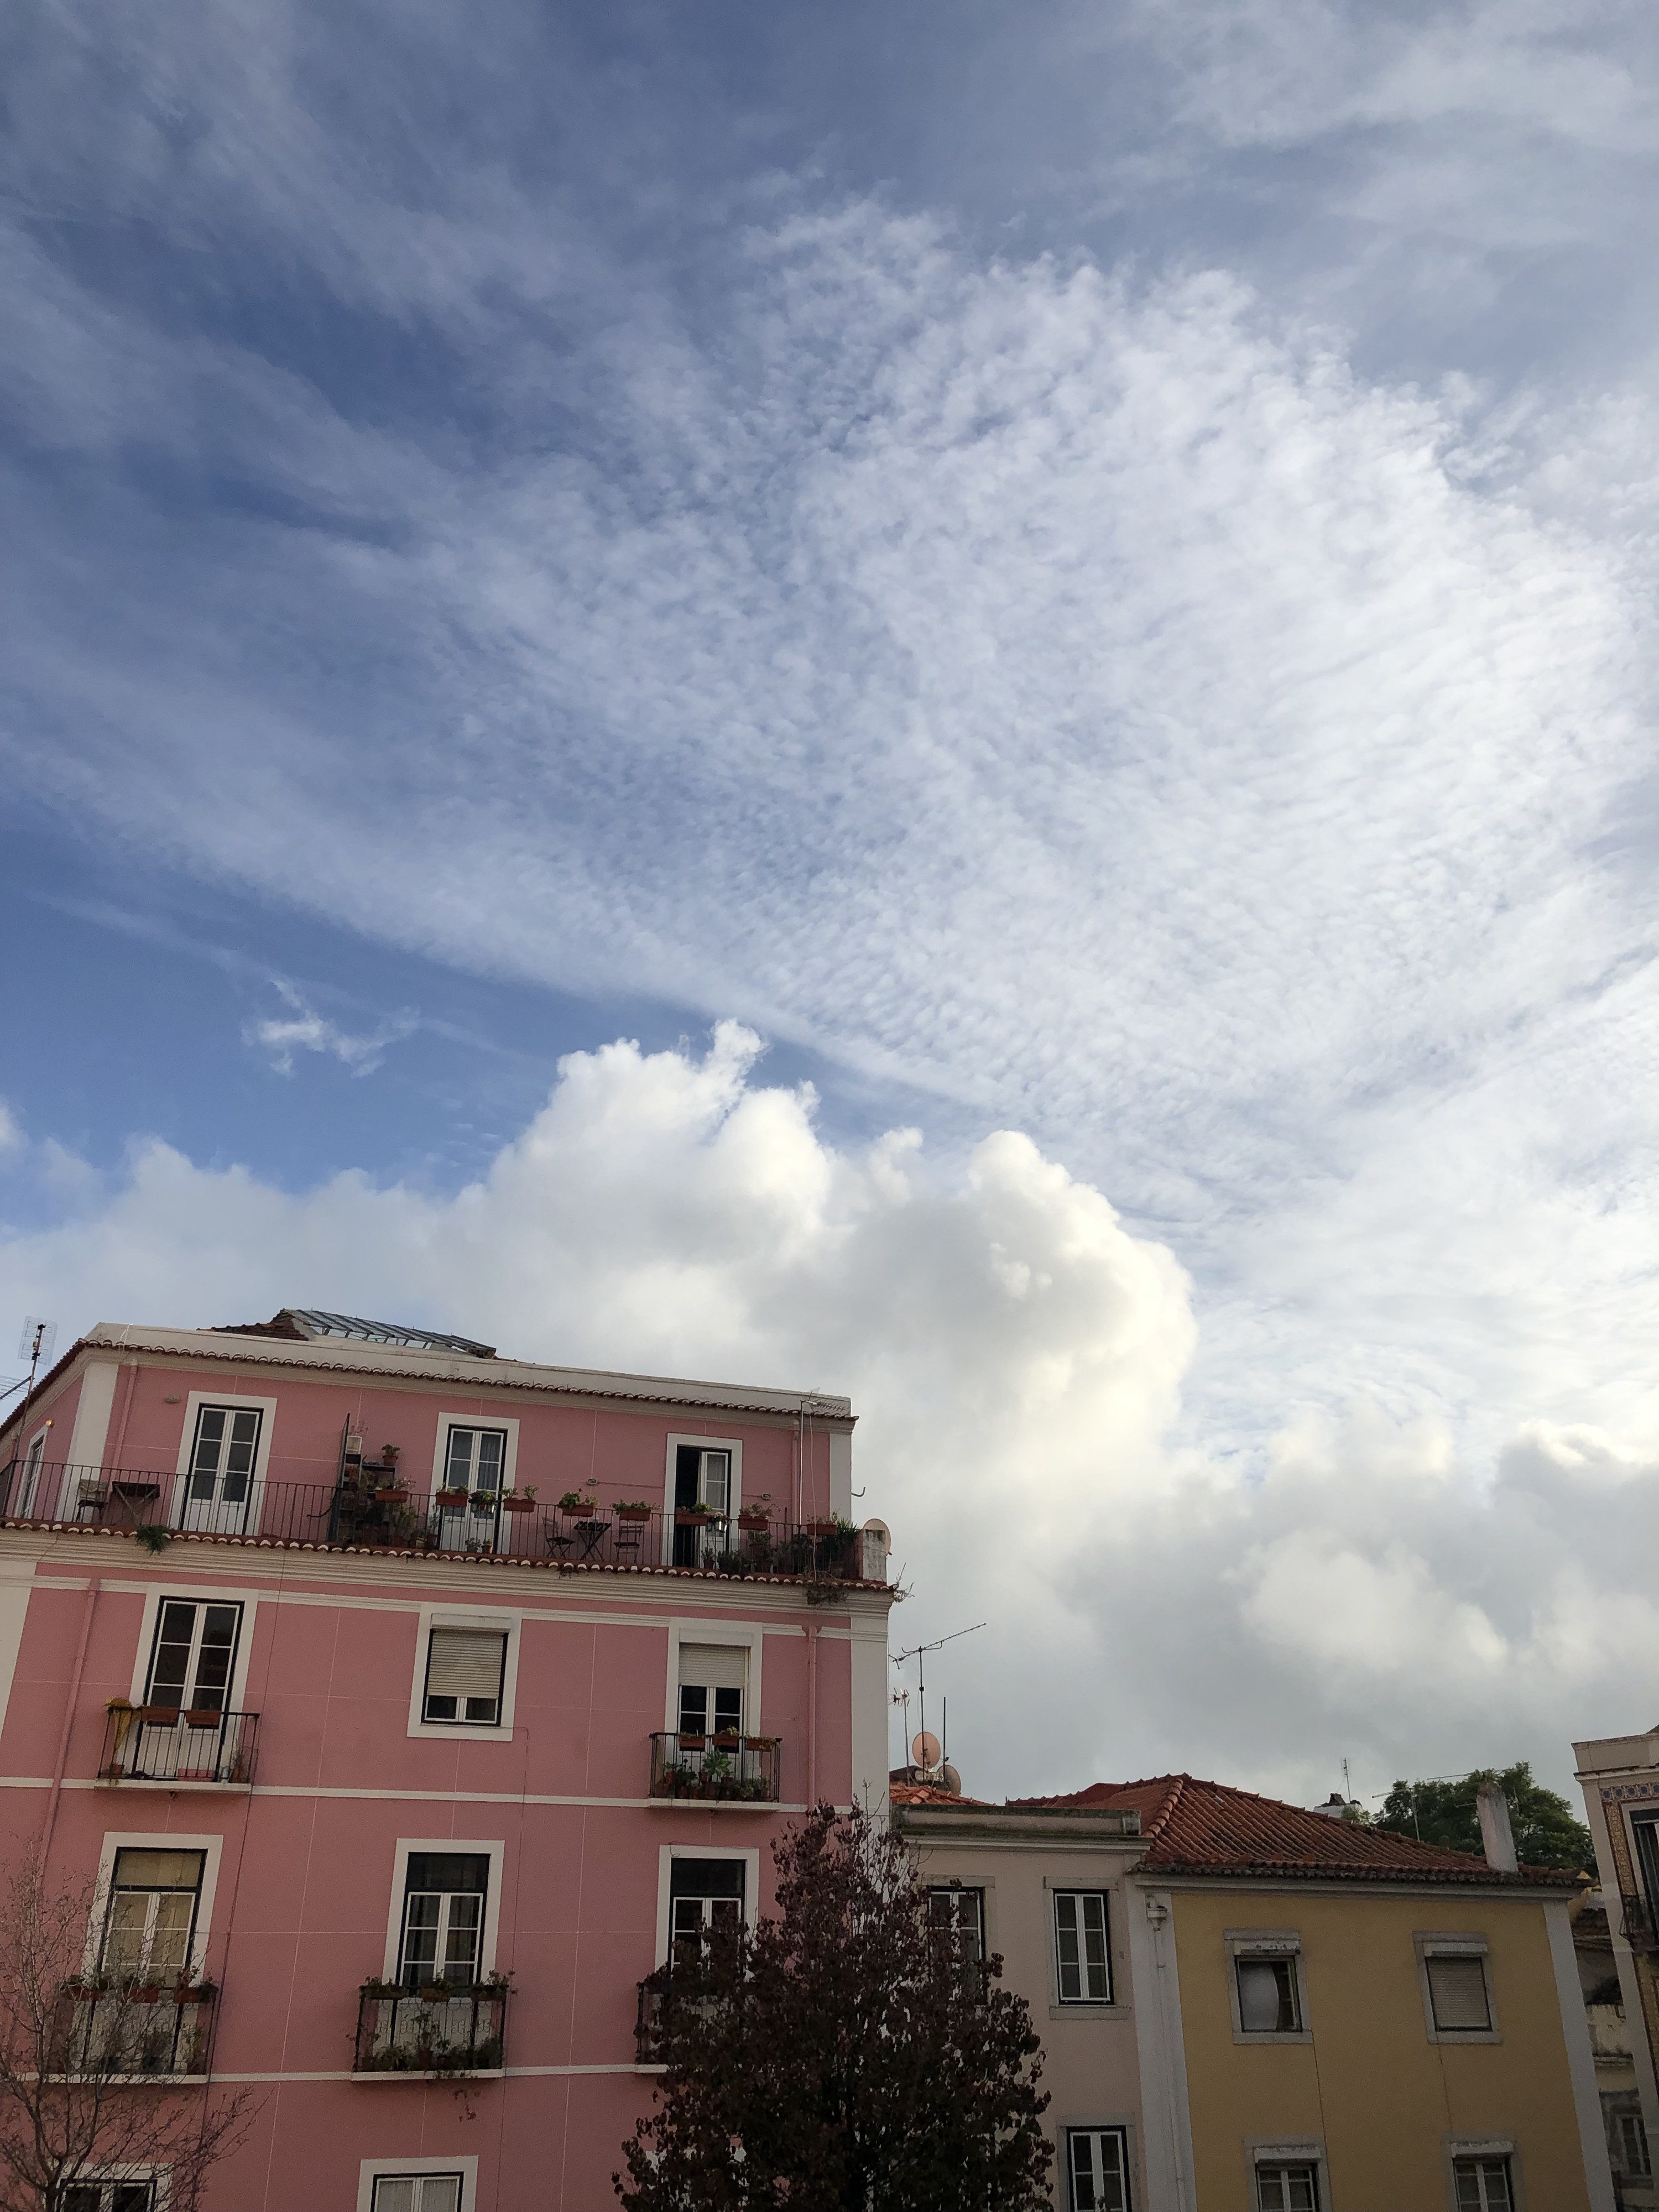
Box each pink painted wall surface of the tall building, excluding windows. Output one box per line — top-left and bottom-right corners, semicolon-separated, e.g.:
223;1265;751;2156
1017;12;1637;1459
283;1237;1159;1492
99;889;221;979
0;1336;876;2212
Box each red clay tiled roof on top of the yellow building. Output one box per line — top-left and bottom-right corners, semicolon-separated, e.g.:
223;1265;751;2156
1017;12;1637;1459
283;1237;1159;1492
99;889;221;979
1009;1774;1579;1889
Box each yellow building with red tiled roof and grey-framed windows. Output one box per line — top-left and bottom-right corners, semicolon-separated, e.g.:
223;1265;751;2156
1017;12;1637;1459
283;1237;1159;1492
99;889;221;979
898;1774;1615;2212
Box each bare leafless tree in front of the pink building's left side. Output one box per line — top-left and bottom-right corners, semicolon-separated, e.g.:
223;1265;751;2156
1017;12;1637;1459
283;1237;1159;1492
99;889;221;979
0;1856;254;2212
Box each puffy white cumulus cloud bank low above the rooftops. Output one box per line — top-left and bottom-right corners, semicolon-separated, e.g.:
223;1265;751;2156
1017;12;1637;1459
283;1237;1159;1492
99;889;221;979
4;1024;1659;1794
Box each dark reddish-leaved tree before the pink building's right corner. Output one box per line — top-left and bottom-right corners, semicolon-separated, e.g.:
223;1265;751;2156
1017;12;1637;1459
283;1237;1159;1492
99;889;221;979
615;1805;1051;2212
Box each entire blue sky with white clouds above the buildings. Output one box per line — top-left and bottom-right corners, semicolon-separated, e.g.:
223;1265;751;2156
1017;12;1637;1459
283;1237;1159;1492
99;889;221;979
0;0;1659;1794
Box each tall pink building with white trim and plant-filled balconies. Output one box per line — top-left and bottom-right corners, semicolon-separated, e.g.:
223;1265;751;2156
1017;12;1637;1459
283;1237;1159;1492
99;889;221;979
0;1312;891;2212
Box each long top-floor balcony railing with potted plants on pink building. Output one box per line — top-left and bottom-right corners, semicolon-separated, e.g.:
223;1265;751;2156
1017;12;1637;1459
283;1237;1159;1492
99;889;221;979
0;1460;887;1586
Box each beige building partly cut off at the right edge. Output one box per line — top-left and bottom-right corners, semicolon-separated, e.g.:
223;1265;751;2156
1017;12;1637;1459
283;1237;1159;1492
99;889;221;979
1573;1728;1659;2212
